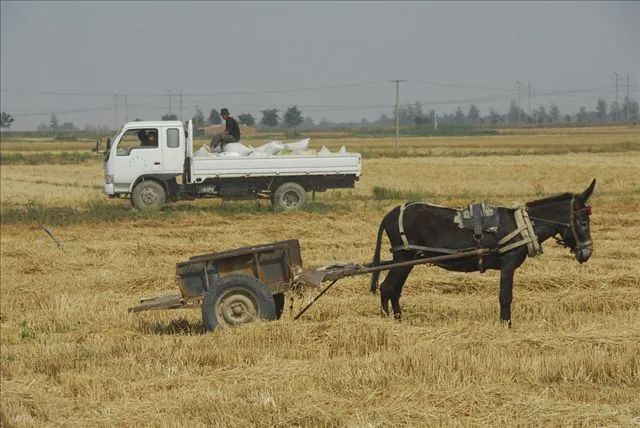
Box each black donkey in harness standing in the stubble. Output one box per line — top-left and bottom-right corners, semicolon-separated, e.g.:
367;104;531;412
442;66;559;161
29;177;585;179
371;179;596;326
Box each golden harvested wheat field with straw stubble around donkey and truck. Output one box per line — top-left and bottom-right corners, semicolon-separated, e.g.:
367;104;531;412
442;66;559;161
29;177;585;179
0;128;640;427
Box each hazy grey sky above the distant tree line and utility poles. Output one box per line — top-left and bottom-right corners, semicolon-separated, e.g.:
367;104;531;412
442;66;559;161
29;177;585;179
0;1;640;129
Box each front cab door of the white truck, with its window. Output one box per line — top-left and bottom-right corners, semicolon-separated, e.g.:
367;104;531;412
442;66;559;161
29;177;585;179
113;128;163;184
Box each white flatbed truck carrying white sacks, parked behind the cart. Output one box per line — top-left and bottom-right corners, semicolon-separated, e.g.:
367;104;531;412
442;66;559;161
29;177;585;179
103;121;361;210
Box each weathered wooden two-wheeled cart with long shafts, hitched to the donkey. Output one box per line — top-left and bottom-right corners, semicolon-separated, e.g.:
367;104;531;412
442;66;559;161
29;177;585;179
129;239;489;331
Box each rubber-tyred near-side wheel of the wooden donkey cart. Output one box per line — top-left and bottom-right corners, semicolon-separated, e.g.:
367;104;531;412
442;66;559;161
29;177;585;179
202;275;276;331
